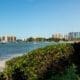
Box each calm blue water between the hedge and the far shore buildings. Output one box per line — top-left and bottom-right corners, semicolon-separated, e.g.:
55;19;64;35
0;42;54;60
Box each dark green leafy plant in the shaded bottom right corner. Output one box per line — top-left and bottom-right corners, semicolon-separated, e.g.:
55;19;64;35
49;64;78;80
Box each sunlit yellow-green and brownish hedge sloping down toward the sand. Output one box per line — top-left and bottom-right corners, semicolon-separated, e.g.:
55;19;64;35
4;44;73;80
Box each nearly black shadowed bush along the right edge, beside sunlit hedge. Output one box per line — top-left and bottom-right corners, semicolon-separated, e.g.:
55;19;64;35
70;43;80;75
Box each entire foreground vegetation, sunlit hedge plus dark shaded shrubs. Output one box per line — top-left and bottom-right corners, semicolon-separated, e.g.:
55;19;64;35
0;43;80;80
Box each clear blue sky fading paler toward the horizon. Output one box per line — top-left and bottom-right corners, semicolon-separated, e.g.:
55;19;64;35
0;0;80;38
